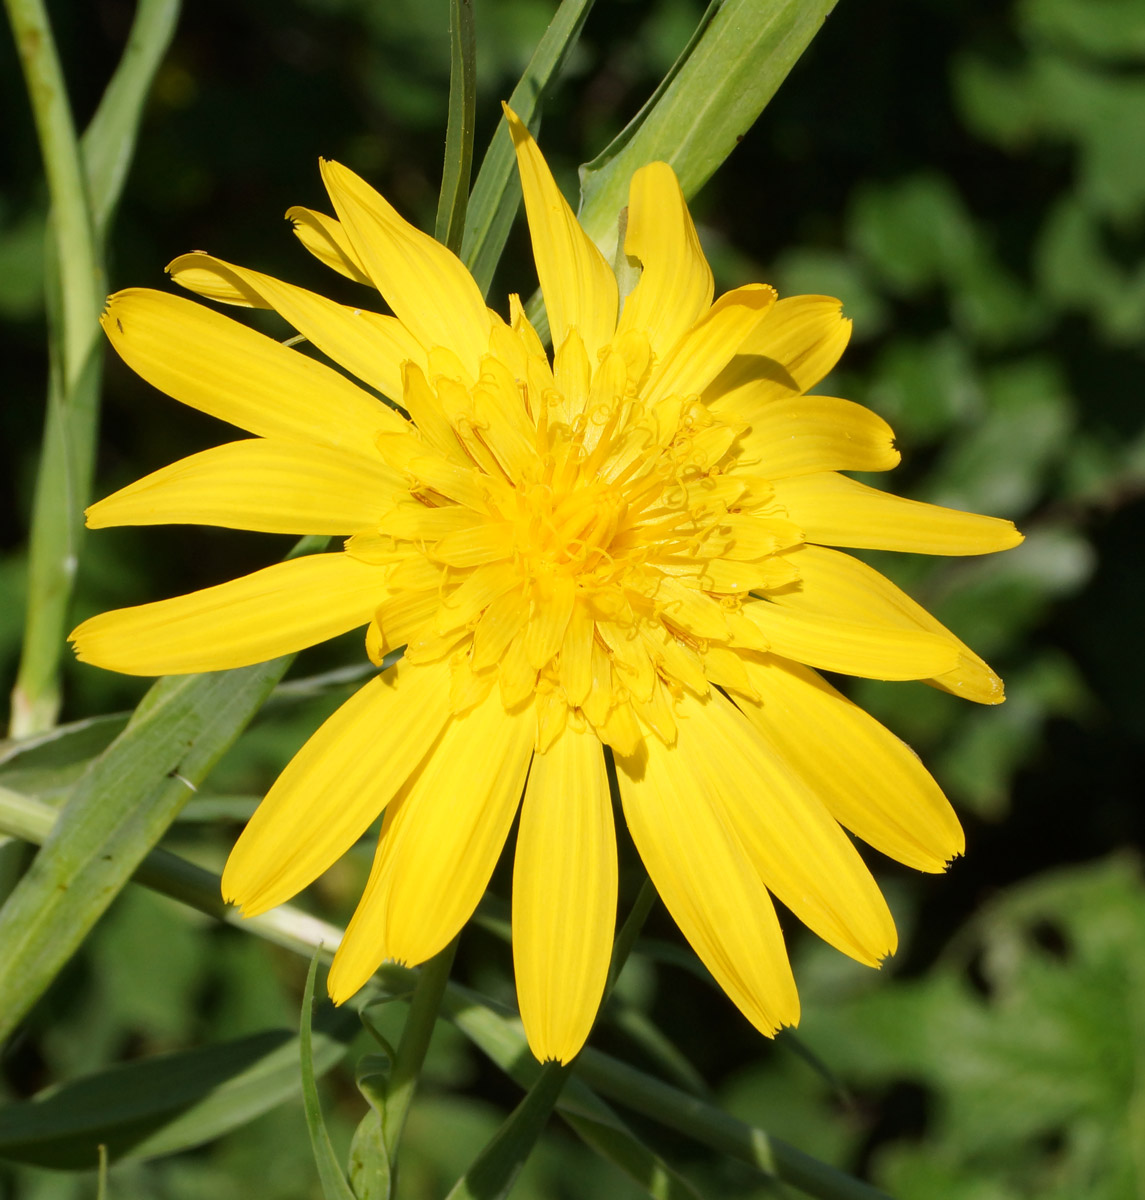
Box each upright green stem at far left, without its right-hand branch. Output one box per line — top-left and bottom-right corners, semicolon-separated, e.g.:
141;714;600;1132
5;0;103;737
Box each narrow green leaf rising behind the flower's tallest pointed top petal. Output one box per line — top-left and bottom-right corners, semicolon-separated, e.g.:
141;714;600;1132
461;0;593;294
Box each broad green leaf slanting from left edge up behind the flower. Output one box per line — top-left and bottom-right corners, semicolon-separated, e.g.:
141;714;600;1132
0;658;290;1038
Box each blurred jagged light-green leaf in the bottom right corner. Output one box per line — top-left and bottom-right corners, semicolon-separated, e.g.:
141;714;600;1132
804;858;1145;1200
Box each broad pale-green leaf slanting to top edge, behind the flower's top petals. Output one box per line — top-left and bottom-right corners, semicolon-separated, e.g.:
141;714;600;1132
580;0;835;260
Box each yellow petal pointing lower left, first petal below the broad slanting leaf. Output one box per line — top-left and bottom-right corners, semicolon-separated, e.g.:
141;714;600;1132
222;662;449;917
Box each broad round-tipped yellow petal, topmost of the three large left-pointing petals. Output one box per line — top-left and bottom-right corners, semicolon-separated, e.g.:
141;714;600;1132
101;288;407;456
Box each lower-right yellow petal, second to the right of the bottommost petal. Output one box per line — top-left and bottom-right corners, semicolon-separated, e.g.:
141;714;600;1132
678;692;897;966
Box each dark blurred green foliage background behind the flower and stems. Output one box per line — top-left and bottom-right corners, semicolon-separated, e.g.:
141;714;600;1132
0;0;1145;1200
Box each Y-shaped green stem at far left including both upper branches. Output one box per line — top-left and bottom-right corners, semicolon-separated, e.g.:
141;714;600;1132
5;0;179;737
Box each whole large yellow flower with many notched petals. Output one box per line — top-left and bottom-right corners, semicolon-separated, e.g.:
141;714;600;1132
72;114;1020;1061
